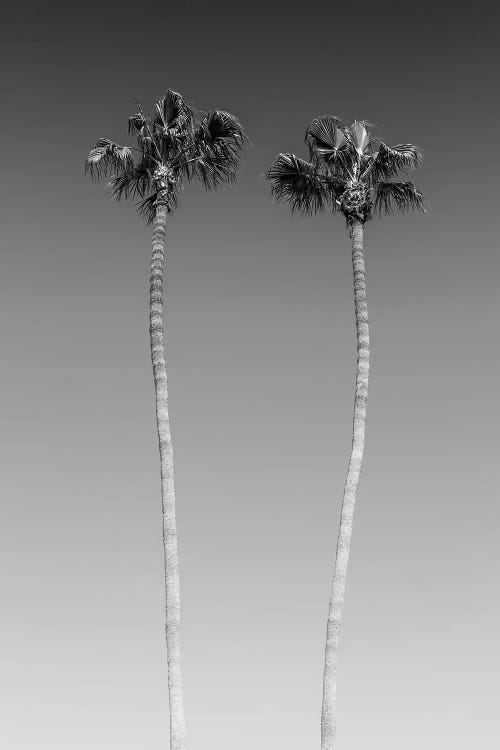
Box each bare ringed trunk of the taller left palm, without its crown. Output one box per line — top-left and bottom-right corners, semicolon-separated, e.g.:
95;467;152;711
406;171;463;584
149;202;186;750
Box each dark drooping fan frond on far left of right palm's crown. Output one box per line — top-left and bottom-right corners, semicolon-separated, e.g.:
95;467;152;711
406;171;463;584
267;154;330;214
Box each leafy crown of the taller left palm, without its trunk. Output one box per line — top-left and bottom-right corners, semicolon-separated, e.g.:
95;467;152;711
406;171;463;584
85;89;247;223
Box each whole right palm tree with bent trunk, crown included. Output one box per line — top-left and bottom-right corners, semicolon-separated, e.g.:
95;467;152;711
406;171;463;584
268;116;424;750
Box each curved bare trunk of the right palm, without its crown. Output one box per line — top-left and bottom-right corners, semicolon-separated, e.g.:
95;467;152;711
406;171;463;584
321;221;370;750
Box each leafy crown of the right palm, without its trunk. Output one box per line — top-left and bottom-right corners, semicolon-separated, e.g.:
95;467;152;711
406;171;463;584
268;115;425;224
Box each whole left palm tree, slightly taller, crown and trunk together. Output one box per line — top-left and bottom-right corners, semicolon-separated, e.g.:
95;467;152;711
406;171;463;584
85;89;246;750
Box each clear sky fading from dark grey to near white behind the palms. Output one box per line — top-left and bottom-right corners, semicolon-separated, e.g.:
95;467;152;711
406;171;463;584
0;0;500;750
